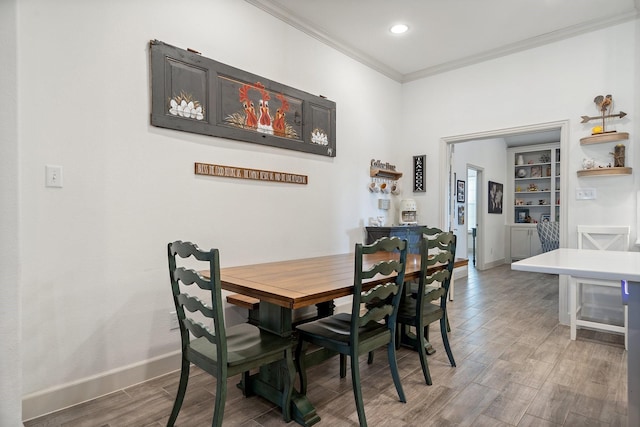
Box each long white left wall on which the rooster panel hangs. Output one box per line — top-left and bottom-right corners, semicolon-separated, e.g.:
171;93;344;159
18;0;401;415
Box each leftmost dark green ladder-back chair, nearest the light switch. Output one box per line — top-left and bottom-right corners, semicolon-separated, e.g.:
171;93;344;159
167;241;295;426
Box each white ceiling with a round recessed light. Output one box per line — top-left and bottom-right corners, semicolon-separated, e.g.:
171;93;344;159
246;0;640;82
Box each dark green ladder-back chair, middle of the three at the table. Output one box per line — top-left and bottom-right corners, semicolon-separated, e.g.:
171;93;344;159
296;237;407;426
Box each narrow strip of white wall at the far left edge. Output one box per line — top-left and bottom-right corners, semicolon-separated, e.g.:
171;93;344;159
0;0;22;426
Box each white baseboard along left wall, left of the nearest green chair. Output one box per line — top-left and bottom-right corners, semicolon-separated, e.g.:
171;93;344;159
22;350;181;421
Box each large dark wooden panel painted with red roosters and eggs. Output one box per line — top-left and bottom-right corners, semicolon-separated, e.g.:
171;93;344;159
150;40;336;157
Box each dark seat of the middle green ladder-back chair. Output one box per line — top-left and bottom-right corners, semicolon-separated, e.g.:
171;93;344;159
297;313;390;344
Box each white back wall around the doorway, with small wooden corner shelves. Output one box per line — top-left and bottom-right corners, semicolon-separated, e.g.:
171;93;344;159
402;21;640;251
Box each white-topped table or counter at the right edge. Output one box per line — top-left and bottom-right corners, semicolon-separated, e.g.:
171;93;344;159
511;248;640;426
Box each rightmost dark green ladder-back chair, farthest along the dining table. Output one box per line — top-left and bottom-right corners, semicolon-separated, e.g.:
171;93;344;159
398;228;456;385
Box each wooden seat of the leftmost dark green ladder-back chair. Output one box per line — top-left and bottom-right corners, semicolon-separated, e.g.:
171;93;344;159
191;323;293;367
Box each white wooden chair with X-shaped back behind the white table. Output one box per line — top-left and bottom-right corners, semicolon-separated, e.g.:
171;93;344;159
569;225;630;348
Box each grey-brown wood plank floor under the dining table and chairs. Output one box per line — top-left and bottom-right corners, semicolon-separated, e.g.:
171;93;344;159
24;265;627;427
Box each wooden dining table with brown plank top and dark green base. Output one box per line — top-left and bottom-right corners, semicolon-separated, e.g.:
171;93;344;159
208;253;467;426
